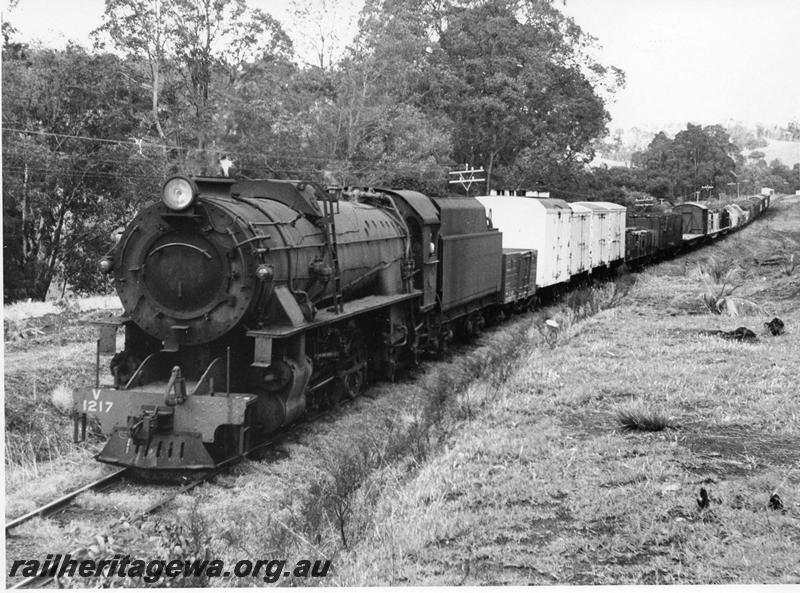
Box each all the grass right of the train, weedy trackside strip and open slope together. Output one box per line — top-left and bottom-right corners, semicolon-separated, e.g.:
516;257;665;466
7;201;800;586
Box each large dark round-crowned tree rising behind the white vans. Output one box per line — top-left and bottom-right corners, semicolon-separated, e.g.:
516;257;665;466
424;0;620;186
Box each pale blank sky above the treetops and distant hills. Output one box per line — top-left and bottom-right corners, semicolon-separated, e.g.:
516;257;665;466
3;0;800;131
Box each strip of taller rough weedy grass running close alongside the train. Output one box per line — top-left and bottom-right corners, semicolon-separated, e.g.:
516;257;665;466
39;276;636;586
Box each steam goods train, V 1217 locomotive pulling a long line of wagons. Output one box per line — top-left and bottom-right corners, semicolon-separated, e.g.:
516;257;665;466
73;177;770;473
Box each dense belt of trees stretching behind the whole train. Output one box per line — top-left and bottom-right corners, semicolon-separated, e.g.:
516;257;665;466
2;0;800;302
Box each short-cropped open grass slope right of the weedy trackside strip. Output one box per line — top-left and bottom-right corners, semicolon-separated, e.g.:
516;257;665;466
322;198;800;585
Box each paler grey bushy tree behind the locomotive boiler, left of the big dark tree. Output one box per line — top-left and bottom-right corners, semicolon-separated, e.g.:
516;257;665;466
260;3;451;187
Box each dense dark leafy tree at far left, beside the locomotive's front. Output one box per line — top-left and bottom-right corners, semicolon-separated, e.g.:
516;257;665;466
3;46;157;299
